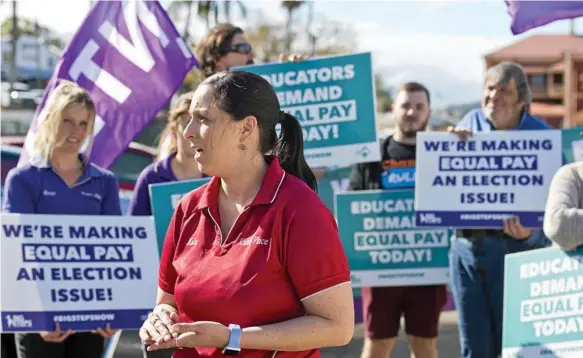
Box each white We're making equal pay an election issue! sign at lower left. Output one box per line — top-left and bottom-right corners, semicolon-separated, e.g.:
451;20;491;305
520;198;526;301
0;214;159;332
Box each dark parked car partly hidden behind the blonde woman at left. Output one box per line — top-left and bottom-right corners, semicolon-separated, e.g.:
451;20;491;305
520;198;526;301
0;136;156;213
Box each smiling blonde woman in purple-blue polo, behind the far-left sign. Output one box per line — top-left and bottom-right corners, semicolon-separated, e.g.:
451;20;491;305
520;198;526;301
3;81;121;358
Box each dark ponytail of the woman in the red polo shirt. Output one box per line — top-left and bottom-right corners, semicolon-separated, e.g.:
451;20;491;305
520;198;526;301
274;111;318;192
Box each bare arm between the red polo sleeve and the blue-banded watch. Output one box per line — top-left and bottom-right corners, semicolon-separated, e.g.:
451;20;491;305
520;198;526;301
241;282;354;351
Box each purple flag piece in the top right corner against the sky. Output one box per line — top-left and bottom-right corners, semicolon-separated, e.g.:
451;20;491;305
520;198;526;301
505;0;583;35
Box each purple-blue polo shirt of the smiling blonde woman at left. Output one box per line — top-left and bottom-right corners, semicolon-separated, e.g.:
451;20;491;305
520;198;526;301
2;156;121;215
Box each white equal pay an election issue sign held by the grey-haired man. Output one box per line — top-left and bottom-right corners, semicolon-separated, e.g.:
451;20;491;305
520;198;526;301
415;130;563;228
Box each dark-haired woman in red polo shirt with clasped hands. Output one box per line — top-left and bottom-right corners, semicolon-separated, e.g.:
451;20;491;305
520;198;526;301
140;71;354;358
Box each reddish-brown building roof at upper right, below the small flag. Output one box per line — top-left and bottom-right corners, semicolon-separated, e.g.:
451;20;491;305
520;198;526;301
485;35;583;62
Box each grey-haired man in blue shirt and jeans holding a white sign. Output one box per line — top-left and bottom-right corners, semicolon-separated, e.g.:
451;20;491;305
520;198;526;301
449;62;552;358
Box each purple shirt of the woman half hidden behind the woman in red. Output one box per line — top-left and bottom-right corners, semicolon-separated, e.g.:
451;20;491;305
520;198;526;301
128;153;178;216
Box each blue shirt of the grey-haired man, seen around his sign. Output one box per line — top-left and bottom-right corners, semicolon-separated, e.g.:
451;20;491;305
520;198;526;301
456;109;566;252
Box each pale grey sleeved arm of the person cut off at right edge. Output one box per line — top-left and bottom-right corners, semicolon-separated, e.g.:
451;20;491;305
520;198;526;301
543;163;583;250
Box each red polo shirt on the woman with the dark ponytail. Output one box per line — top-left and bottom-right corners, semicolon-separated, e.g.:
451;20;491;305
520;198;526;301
159;158;350;358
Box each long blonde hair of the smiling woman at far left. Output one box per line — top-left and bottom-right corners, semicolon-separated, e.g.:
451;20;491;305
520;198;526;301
33;80;95;160
